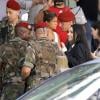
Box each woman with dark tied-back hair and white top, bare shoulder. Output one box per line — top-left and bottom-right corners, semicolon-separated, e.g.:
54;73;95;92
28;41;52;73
43;11;61;48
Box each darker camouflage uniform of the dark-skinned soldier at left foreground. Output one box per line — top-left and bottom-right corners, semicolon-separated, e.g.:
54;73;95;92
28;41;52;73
0;38;27;100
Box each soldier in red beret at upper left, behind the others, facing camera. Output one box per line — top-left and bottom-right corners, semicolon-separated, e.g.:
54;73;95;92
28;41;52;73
0;0;20;44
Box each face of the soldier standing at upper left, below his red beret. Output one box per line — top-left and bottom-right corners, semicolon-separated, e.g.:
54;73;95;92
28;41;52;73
6;8;20;22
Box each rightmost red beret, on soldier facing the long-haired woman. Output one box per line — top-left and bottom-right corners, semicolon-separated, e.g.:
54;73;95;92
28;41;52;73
58;10;75;22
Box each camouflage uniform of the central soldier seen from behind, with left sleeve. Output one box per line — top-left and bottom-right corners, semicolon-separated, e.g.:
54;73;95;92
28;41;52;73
24;38;68;90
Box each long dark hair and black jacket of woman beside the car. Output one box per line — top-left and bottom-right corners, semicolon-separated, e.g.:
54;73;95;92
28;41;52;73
66;24;92;67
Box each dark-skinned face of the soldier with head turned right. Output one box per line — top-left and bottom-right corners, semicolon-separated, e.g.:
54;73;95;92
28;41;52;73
17;27;30;40
